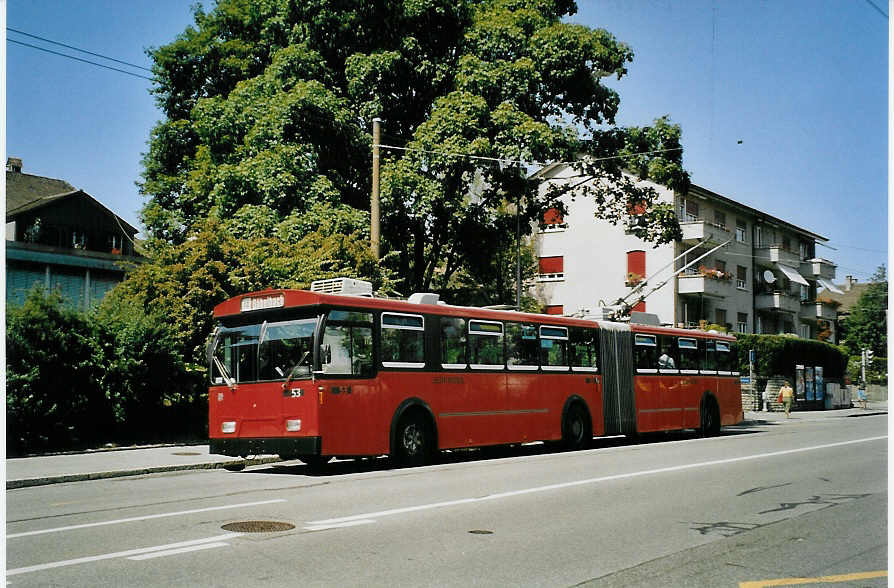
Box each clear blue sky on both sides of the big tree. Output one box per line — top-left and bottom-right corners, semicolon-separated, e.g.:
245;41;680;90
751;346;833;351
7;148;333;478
6;0;888;282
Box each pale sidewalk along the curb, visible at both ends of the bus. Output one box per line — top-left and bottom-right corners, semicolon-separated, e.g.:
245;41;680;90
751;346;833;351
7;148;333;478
6;402;888;490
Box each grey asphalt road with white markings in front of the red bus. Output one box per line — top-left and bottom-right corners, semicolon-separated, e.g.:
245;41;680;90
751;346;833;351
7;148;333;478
6;415;888;588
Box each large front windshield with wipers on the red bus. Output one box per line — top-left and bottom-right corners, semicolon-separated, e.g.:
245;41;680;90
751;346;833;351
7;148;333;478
211;318;317;384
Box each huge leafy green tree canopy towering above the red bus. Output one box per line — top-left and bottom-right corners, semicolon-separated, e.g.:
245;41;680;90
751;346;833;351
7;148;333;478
147;0;688;291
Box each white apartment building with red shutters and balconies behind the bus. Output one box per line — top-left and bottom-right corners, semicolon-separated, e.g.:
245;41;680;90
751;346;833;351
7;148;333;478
531;164;838;342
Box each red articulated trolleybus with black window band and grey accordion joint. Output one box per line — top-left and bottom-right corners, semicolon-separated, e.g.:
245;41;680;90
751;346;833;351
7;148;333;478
208;279;743;465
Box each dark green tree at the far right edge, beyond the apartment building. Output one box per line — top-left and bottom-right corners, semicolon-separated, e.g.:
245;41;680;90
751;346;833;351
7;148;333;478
842;265;888;357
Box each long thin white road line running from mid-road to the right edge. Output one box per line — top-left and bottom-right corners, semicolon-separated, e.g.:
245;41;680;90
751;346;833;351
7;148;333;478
304;435;888;530
